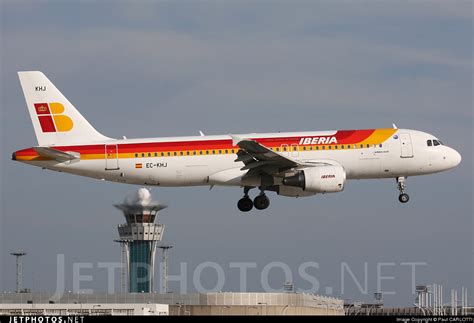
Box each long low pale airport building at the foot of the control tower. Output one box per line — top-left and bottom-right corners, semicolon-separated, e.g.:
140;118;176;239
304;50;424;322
0;292;344;315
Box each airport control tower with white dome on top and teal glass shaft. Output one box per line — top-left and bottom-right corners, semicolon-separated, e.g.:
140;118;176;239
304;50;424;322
114;188;166;293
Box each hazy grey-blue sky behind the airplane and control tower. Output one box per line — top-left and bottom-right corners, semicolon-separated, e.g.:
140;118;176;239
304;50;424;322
0;1;474;305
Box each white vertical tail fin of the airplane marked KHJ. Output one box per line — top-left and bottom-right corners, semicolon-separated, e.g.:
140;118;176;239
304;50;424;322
18;72;110;146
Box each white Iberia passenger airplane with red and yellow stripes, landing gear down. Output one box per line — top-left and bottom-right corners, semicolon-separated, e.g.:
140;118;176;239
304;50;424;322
12;71;461;212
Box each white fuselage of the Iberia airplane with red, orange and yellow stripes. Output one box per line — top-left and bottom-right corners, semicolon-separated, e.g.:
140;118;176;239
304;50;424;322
14;129;461;192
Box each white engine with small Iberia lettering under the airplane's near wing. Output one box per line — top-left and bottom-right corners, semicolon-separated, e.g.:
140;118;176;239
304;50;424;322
283;166;346;193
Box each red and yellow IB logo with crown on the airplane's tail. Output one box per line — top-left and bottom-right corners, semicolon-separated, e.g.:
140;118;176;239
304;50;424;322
35;102;74;132
